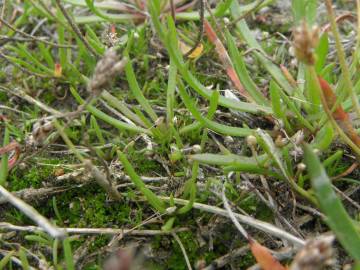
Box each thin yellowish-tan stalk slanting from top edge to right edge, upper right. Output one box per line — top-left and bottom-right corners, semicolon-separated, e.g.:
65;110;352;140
325;0;360;117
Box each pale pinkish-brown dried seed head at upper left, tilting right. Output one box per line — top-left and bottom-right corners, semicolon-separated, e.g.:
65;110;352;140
87;48;128;96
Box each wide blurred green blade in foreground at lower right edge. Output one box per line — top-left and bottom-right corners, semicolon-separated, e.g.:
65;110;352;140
304;145;360;260
